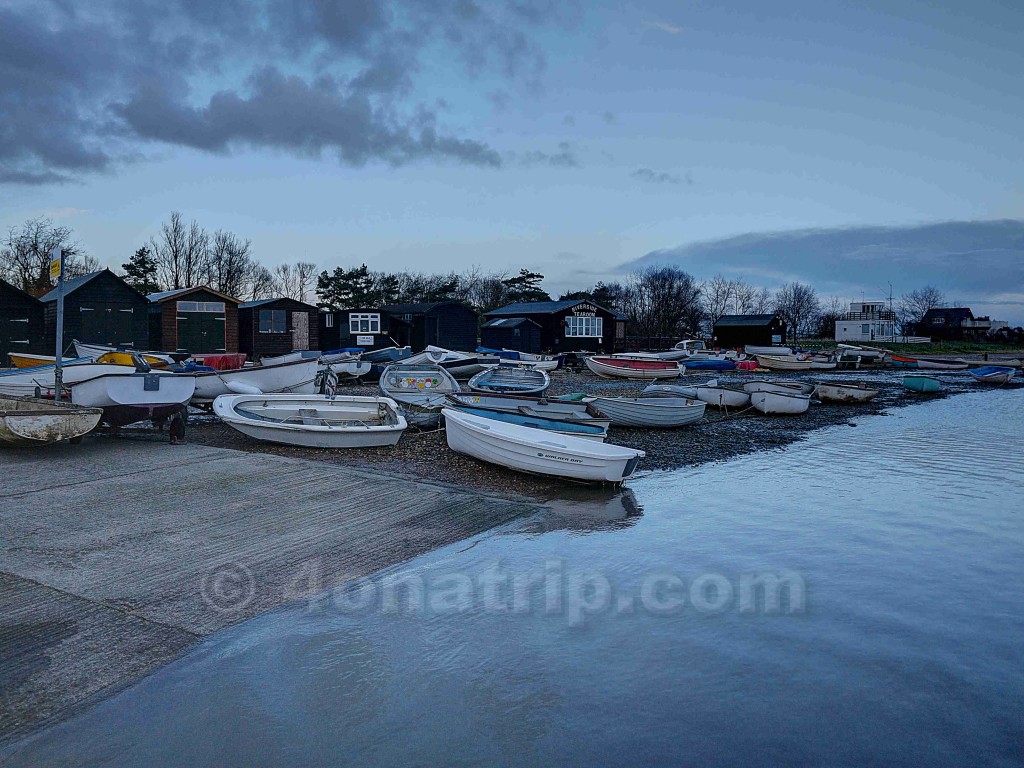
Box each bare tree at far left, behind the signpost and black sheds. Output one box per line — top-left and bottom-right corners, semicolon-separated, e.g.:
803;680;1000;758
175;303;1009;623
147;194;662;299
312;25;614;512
0;217;88;296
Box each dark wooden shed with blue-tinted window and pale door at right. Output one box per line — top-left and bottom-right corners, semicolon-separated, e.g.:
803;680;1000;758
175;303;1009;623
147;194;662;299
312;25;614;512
239;297;321;360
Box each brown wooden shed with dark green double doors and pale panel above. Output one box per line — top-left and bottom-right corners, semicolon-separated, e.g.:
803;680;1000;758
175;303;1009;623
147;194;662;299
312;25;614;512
148;286;241;354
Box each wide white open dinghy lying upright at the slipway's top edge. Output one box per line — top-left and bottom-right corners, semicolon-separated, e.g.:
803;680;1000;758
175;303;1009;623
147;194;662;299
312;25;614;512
213;394;408;449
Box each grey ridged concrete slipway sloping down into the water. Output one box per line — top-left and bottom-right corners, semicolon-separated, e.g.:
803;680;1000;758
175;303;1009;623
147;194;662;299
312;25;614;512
0;438;537;742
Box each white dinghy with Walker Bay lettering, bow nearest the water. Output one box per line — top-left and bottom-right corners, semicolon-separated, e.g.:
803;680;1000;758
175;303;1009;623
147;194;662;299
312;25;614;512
442;408;644;482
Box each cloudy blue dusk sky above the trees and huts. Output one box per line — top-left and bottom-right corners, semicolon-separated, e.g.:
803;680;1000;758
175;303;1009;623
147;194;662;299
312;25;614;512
0;0;1024;324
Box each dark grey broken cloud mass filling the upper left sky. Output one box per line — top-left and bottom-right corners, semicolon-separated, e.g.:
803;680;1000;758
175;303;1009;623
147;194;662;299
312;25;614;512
0;0;577;183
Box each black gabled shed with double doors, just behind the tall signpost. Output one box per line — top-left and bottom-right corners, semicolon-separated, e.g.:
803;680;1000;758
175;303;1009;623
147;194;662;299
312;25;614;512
40;269;150;354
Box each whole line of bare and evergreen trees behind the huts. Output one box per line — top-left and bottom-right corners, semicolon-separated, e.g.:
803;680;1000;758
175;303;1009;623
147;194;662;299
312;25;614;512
0;211;962;338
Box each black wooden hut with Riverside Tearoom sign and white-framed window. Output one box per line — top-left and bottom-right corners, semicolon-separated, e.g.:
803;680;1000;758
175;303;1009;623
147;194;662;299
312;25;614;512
483;299;626;353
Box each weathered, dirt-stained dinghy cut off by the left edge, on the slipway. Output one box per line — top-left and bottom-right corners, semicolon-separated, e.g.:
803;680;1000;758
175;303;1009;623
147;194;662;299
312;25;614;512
0;395;103;447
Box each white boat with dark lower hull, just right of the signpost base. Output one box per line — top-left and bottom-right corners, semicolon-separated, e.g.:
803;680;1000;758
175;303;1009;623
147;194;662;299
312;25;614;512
71;372;196;427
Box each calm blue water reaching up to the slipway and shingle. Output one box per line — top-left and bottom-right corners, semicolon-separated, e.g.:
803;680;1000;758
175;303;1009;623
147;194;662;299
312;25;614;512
8;390;1024;766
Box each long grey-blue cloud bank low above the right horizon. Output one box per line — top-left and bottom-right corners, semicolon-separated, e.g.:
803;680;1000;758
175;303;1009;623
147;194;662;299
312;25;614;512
626;220;1024;298
